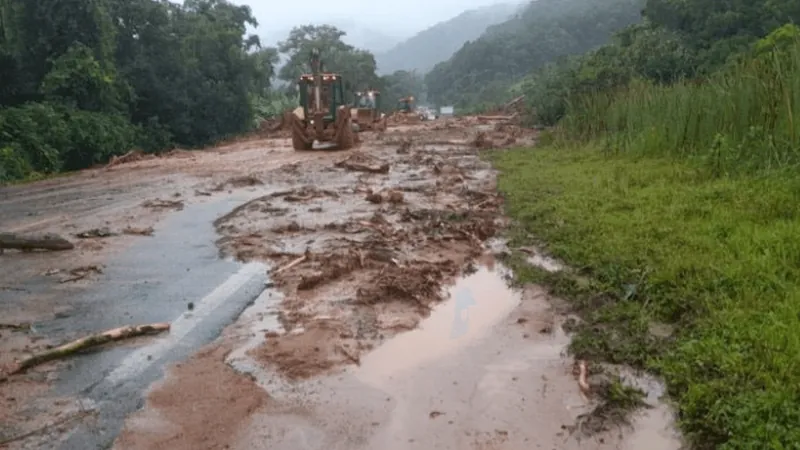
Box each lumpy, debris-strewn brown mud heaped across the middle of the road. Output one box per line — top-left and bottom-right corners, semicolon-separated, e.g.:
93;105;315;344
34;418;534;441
209;118;520;380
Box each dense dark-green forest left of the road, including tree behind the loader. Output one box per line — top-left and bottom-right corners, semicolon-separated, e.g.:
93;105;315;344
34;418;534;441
0;0;412;182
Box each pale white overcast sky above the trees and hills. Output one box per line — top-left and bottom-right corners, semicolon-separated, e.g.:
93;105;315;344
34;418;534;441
232;0;504;37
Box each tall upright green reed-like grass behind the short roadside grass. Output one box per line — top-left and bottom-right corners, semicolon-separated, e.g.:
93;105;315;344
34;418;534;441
561;40;800;175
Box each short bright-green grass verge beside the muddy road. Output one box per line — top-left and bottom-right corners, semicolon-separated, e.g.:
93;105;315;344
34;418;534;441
494;144;800;449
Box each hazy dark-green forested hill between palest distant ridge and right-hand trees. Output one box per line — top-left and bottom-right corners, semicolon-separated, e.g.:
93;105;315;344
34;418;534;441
425;0;644;106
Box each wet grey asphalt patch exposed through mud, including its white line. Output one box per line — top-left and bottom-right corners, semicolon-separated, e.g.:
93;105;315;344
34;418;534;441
15;198;267;450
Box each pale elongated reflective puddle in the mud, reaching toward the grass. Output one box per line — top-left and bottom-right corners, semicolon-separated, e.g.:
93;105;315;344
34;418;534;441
356;265;521;384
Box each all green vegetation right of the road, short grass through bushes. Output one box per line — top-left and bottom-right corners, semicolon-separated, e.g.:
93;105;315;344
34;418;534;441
495;5;800;449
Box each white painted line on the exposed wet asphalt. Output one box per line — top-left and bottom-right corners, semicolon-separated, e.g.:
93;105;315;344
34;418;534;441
106;263;267;384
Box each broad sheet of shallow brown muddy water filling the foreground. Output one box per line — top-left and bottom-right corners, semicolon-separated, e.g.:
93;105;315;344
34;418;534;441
223;265;680;450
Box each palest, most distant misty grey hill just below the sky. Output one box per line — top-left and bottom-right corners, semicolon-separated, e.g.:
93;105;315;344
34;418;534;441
375;3;519;74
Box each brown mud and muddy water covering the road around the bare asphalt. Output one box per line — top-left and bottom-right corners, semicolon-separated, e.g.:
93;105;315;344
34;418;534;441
0;118;679;450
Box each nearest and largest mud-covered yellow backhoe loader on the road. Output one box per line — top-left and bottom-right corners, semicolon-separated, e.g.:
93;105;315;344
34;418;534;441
287;49;358;150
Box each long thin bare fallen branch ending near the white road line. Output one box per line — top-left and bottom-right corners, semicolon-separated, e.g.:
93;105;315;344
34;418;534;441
10;323;170;375
